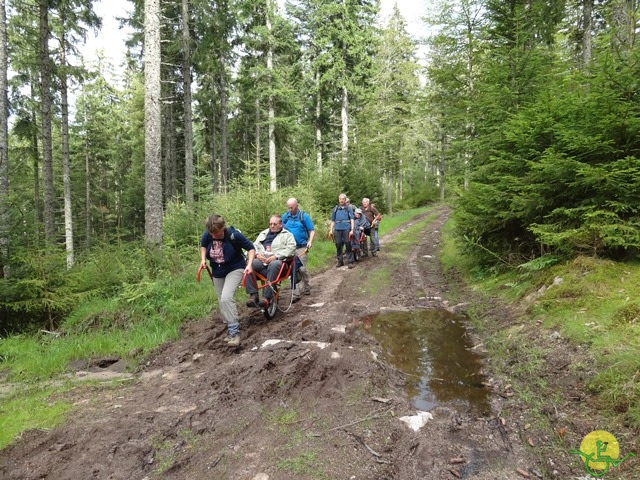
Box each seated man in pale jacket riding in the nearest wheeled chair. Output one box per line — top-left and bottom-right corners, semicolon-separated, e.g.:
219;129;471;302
246;215;296;309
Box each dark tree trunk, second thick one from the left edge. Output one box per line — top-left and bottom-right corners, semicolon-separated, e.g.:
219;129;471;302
39;0;56;243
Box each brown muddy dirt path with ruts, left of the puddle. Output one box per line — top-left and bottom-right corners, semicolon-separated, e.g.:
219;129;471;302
0;207;540;480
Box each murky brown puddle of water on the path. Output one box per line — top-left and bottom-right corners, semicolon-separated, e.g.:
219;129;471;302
364;309;491;416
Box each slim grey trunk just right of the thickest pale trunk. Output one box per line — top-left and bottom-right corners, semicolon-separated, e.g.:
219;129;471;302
182;0;193;203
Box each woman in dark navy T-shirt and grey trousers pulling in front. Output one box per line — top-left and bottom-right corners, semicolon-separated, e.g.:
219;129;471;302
200;215;256;347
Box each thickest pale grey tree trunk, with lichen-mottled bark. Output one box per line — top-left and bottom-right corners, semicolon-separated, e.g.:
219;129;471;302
144;0;163;245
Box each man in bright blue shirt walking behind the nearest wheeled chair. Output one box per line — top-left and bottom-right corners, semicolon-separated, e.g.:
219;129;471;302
282;197;316;301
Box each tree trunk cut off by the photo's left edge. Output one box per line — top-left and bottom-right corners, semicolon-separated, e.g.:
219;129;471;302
0;0;10;278
